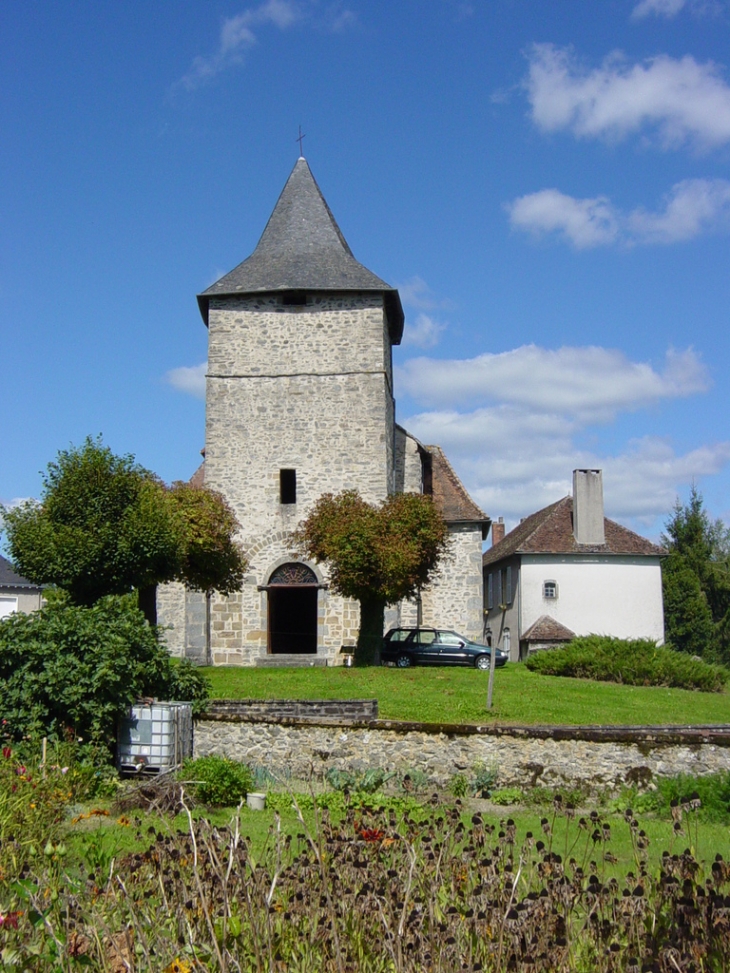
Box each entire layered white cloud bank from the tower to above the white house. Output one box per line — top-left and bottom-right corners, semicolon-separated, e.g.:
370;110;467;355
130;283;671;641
396;345;730;526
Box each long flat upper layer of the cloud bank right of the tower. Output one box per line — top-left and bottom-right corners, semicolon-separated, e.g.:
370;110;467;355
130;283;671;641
396;345;710;423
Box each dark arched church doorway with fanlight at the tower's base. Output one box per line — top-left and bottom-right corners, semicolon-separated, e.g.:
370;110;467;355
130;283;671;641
266;561;319;655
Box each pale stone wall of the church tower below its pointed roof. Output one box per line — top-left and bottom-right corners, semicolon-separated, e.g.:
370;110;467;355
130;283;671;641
205;294;394;665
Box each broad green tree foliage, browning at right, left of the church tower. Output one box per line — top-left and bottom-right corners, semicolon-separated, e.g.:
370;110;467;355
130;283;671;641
3;438;245;621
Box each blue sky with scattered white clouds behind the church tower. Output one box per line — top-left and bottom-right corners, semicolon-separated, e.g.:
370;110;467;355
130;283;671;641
0;0;730;536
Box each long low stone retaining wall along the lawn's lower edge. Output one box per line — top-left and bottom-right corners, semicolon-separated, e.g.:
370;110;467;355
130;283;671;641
195;716;730;788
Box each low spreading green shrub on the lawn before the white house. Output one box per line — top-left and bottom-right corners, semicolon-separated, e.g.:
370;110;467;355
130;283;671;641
525;635;730;692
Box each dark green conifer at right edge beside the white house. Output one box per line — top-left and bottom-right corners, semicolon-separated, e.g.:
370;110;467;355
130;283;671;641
662;486;730;661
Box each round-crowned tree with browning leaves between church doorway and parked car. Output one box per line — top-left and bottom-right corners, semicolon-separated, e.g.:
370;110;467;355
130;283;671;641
293;490;448;665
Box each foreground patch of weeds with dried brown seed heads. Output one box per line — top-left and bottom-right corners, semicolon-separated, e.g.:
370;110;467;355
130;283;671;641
0;795;730;973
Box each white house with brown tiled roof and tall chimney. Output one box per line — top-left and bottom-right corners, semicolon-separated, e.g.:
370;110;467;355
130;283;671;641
482;470;666;660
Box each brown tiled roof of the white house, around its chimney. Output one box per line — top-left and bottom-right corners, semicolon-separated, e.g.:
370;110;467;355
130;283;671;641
482;497;667;564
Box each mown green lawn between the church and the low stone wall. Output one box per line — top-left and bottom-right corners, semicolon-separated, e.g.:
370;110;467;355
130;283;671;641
202;663;730;726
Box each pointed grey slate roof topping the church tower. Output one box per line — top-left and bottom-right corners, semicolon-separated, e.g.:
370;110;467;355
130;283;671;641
198;158;403;344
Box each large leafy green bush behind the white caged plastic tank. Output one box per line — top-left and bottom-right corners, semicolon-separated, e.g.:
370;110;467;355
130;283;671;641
0;597;207;751
